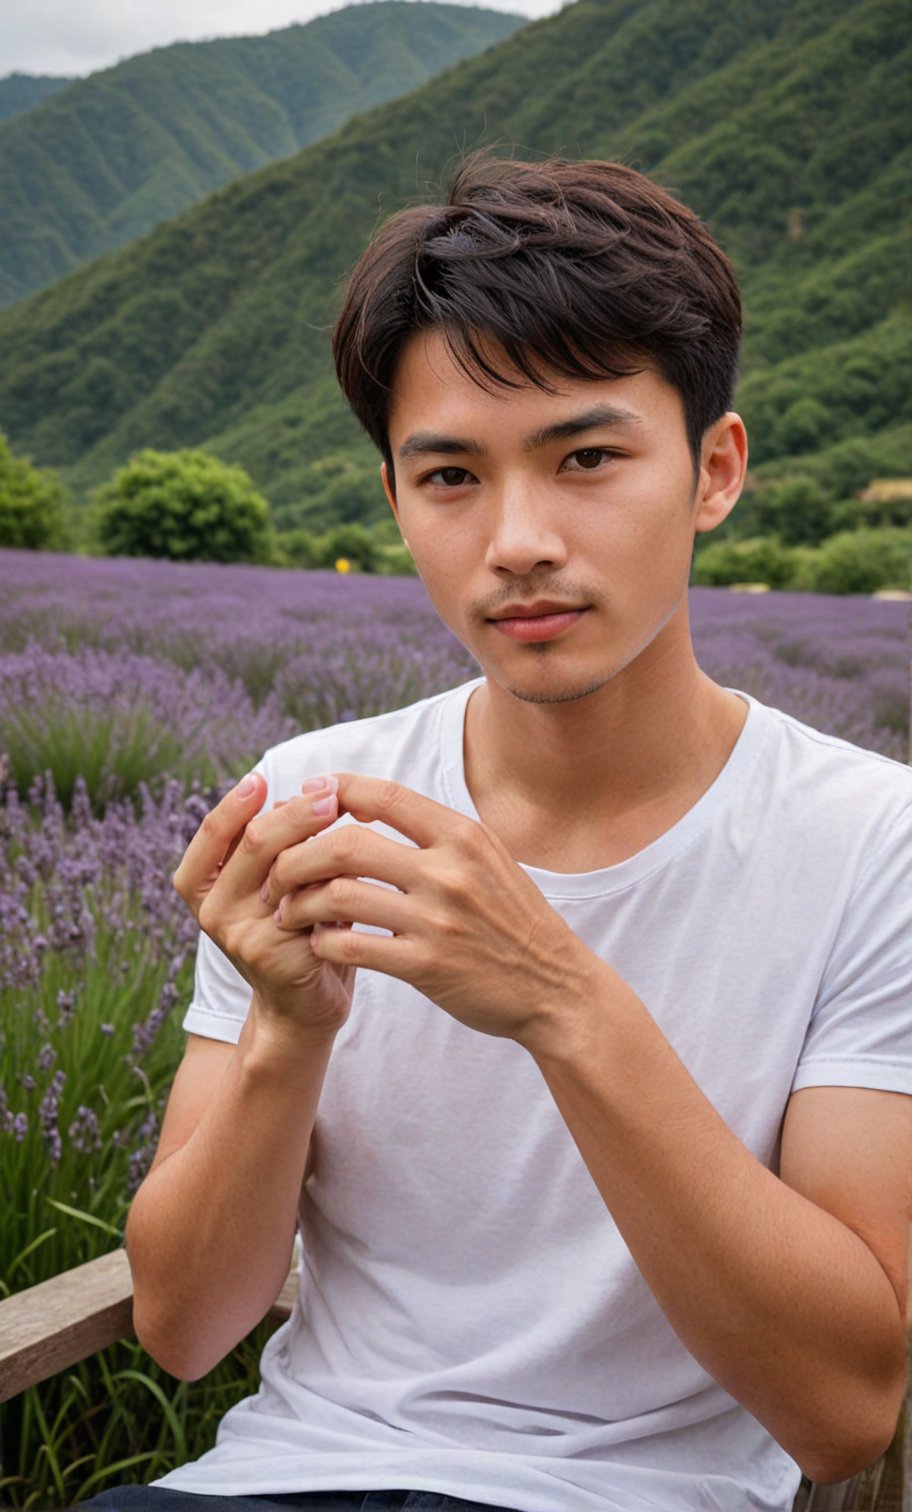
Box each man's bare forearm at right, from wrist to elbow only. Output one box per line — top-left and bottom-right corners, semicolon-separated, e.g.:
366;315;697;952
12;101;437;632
532;968;904;1480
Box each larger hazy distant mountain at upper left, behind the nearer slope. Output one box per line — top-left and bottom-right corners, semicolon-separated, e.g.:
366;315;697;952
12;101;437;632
0;0;525;305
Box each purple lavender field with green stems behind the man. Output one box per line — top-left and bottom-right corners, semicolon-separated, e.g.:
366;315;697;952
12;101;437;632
0;552;909;1507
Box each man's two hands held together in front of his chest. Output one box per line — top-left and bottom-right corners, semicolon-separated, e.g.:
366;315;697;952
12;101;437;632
174;773;603;1049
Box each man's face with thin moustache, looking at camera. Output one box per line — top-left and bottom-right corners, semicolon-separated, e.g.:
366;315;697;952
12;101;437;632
390;333;735;703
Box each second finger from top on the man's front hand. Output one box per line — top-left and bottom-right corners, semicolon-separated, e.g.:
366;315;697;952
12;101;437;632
263;824;420;907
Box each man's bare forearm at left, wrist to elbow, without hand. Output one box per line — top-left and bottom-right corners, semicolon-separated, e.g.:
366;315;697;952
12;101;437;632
127;1012;333;1379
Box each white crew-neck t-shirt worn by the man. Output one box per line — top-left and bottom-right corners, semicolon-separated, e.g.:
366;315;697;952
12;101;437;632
156;680;912;1512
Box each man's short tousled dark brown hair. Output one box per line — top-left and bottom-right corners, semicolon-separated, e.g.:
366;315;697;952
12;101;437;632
333;151;741;466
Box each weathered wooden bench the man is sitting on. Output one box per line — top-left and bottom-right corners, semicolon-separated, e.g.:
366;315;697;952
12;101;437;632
0;1249;912;1512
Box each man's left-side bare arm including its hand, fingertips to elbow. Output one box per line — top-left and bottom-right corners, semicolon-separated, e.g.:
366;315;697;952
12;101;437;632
127;777;354;1379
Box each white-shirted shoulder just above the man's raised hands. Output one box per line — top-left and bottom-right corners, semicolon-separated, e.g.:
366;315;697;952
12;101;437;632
259;680;476;803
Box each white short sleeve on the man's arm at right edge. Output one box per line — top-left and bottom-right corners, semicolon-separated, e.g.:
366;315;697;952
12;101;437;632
793;807;912;1093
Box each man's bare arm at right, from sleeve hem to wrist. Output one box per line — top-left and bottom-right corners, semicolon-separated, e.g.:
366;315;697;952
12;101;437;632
535;978;912;1482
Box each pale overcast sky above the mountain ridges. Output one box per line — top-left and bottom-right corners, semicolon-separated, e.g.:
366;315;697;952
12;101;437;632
0;0;561;77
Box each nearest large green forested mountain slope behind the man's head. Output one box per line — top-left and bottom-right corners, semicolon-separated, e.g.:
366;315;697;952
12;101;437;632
0;0;912;526
